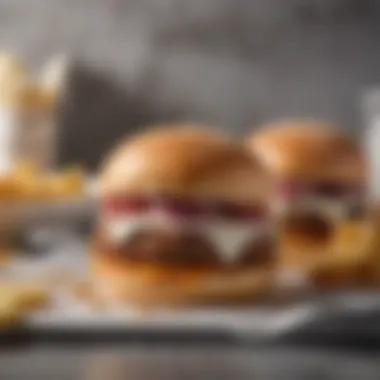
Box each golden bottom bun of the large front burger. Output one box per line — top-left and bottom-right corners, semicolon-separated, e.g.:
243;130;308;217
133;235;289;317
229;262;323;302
92;254;274;305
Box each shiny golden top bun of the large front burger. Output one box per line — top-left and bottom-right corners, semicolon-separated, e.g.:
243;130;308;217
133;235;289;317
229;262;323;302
101;125;265;203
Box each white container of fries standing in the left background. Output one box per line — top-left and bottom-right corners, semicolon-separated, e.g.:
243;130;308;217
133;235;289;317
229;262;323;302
0;53;67;174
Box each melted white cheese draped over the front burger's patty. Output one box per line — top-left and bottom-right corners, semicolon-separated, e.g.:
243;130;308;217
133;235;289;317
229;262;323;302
107;213;267;262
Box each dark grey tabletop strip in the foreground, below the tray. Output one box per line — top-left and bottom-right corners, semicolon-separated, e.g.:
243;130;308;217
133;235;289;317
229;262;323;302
0;345;380;380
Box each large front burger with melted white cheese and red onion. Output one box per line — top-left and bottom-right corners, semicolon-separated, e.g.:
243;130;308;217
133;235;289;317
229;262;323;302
92;125;275;305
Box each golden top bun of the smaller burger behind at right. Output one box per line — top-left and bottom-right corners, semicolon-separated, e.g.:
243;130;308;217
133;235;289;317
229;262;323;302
247;120;366;182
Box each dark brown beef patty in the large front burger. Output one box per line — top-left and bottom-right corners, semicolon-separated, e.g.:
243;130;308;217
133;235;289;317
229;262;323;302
97;230;275;269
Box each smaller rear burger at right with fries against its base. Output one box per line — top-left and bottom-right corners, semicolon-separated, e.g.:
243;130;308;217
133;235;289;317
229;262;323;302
248;120;372;286
